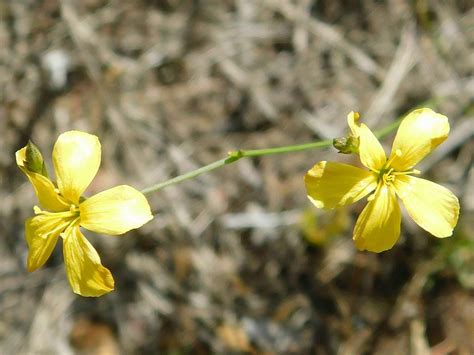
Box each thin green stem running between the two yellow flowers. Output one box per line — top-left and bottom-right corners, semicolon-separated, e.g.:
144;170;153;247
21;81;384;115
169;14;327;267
142;119;401;194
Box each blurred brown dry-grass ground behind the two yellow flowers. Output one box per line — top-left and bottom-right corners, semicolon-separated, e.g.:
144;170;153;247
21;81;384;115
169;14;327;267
0;0;474;355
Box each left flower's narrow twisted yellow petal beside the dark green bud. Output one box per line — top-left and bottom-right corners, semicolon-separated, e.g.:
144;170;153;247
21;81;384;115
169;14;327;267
15;147;69;212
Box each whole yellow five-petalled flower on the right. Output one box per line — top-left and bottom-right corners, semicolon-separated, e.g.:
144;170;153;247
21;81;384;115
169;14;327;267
305;108;459;253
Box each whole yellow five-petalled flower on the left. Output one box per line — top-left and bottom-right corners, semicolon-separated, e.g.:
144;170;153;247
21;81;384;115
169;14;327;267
16;131;153;297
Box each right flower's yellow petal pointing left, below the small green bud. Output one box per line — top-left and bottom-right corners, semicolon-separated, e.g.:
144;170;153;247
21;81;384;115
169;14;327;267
304;161;377;208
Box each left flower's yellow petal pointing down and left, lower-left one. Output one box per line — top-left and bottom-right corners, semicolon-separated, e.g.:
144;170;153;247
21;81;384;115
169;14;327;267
25;215;67;272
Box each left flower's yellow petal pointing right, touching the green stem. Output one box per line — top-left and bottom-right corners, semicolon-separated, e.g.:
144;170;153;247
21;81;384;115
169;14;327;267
79;185;153;235
